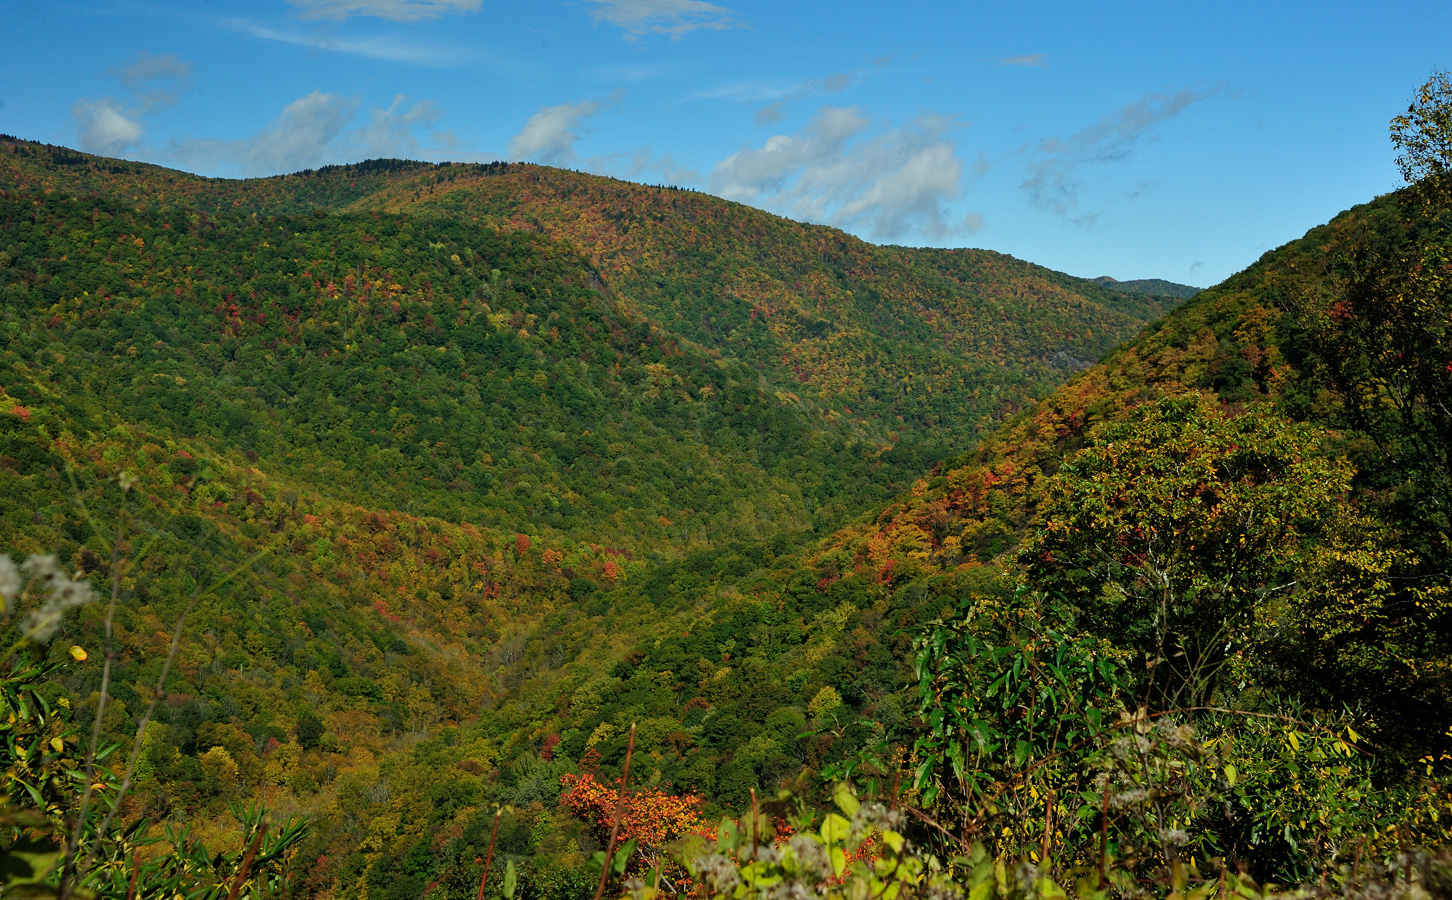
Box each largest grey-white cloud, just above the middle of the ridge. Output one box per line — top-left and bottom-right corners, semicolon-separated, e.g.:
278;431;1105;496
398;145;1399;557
711;106;983;240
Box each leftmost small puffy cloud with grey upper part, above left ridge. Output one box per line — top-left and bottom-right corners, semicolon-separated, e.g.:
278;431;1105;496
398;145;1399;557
71;51;192;157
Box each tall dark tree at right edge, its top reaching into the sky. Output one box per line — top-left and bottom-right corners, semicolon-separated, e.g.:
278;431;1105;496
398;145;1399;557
1278;71;1452;758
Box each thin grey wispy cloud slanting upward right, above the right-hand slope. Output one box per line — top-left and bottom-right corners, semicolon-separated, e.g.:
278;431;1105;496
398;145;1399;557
1019;83;1237;225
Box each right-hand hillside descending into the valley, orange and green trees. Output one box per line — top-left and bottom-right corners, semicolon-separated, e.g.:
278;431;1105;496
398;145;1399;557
423;180;1452;894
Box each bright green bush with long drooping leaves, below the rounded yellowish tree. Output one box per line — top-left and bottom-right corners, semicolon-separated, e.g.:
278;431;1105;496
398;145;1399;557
912;591;1127;856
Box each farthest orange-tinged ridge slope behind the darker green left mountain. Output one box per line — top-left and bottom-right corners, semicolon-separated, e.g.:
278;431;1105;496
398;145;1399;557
353;165;1178;443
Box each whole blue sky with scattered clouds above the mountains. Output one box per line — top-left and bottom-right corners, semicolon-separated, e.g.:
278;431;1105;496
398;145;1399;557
0;0;1452;286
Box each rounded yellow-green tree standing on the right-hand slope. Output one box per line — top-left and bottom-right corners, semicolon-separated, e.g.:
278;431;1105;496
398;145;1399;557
1022;395;1352;703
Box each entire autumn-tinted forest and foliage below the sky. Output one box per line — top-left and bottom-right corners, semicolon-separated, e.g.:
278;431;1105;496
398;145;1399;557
0;78;1452;900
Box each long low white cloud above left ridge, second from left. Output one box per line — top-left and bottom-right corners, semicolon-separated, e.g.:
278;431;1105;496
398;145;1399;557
170;90;452;176
